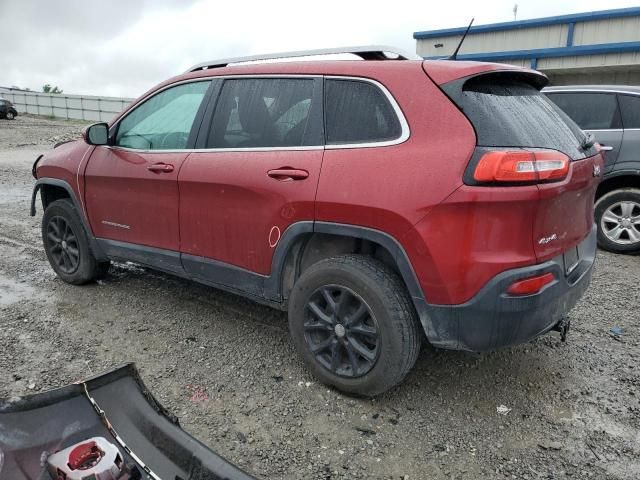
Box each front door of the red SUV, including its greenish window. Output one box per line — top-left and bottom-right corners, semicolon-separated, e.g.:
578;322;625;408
85;81;211;256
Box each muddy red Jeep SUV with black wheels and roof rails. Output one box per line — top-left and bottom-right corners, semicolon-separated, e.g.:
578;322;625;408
31;48;603;395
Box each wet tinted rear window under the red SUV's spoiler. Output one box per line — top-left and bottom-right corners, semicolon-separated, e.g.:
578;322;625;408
445;74;595;159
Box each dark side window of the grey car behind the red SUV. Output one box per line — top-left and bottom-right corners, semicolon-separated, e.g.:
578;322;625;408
547;92;622;130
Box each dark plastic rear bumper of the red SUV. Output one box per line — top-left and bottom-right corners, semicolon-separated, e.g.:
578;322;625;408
414;225;596;352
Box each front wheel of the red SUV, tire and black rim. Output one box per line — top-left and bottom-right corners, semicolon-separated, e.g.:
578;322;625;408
42;199;104;285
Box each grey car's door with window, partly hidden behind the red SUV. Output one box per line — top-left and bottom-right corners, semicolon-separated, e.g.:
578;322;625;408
545;91;623;172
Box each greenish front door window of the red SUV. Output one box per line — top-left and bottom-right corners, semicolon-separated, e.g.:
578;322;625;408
116;81;210;150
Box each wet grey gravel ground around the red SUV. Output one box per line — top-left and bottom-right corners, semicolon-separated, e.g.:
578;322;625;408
0;116;640;479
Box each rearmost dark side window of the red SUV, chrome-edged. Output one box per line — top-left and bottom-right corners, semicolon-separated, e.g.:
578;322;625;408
324;79;402;145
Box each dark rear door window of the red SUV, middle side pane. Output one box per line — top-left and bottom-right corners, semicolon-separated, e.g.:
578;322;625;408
207;78;321;148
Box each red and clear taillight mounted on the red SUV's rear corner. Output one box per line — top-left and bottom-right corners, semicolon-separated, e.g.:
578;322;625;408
473;150;569;183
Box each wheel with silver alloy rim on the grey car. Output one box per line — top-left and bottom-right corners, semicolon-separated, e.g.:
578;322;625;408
595;188;640;253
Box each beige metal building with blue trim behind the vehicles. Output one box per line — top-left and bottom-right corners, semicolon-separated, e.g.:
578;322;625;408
413;7;640;85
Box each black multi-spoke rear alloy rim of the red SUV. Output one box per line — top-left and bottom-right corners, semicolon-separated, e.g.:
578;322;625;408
303;285;380;378
